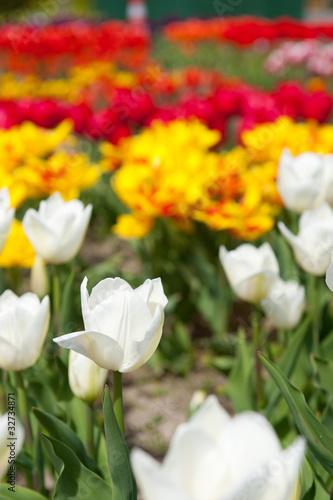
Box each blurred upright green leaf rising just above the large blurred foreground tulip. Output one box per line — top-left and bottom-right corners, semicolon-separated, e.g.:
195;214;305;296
226;330;256;412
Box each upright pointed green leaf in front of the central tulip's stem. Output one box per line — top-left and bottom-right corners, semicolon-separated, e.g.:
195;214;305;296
103;387;137;500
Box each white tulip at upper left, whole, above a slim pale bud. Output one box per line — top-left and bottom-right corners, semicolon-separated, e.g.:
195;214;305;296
22;193;92;264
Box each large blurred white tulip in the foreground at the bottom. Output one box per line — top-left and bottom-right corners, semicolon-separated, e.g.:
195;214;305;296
131;396;305;500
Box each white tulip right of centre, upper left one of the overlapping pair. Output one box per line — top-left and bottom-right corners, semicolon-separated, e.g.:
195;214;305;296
219;243;279;302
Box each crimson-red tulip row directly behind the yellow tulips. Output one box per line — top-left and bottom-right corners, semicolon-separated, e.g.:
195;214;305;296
0;83;333;143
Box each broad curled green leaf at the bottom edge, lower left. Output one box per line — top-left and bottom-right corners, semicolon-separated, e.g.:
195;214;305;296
42;435;112;500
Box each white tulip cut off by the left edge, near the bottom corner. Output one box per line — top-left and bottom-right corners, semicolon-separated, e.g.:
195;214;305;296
0;413;24;481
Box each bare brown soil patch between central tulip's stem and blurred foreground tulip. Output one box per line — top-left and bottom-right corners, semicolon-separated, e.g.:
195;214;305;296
123;363;230;458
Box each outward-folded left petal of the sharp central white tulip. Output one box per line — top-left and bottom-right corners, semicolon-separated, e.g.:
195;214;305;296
53;332;124;371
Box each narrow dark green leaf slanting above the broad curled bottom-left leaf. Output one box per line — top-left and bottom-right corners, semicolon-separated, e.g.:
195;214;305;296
32;408;99;473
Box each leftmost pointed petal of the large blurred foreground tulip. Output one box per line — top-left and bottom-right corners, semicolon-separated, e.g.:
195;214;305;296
131;449;193;500
